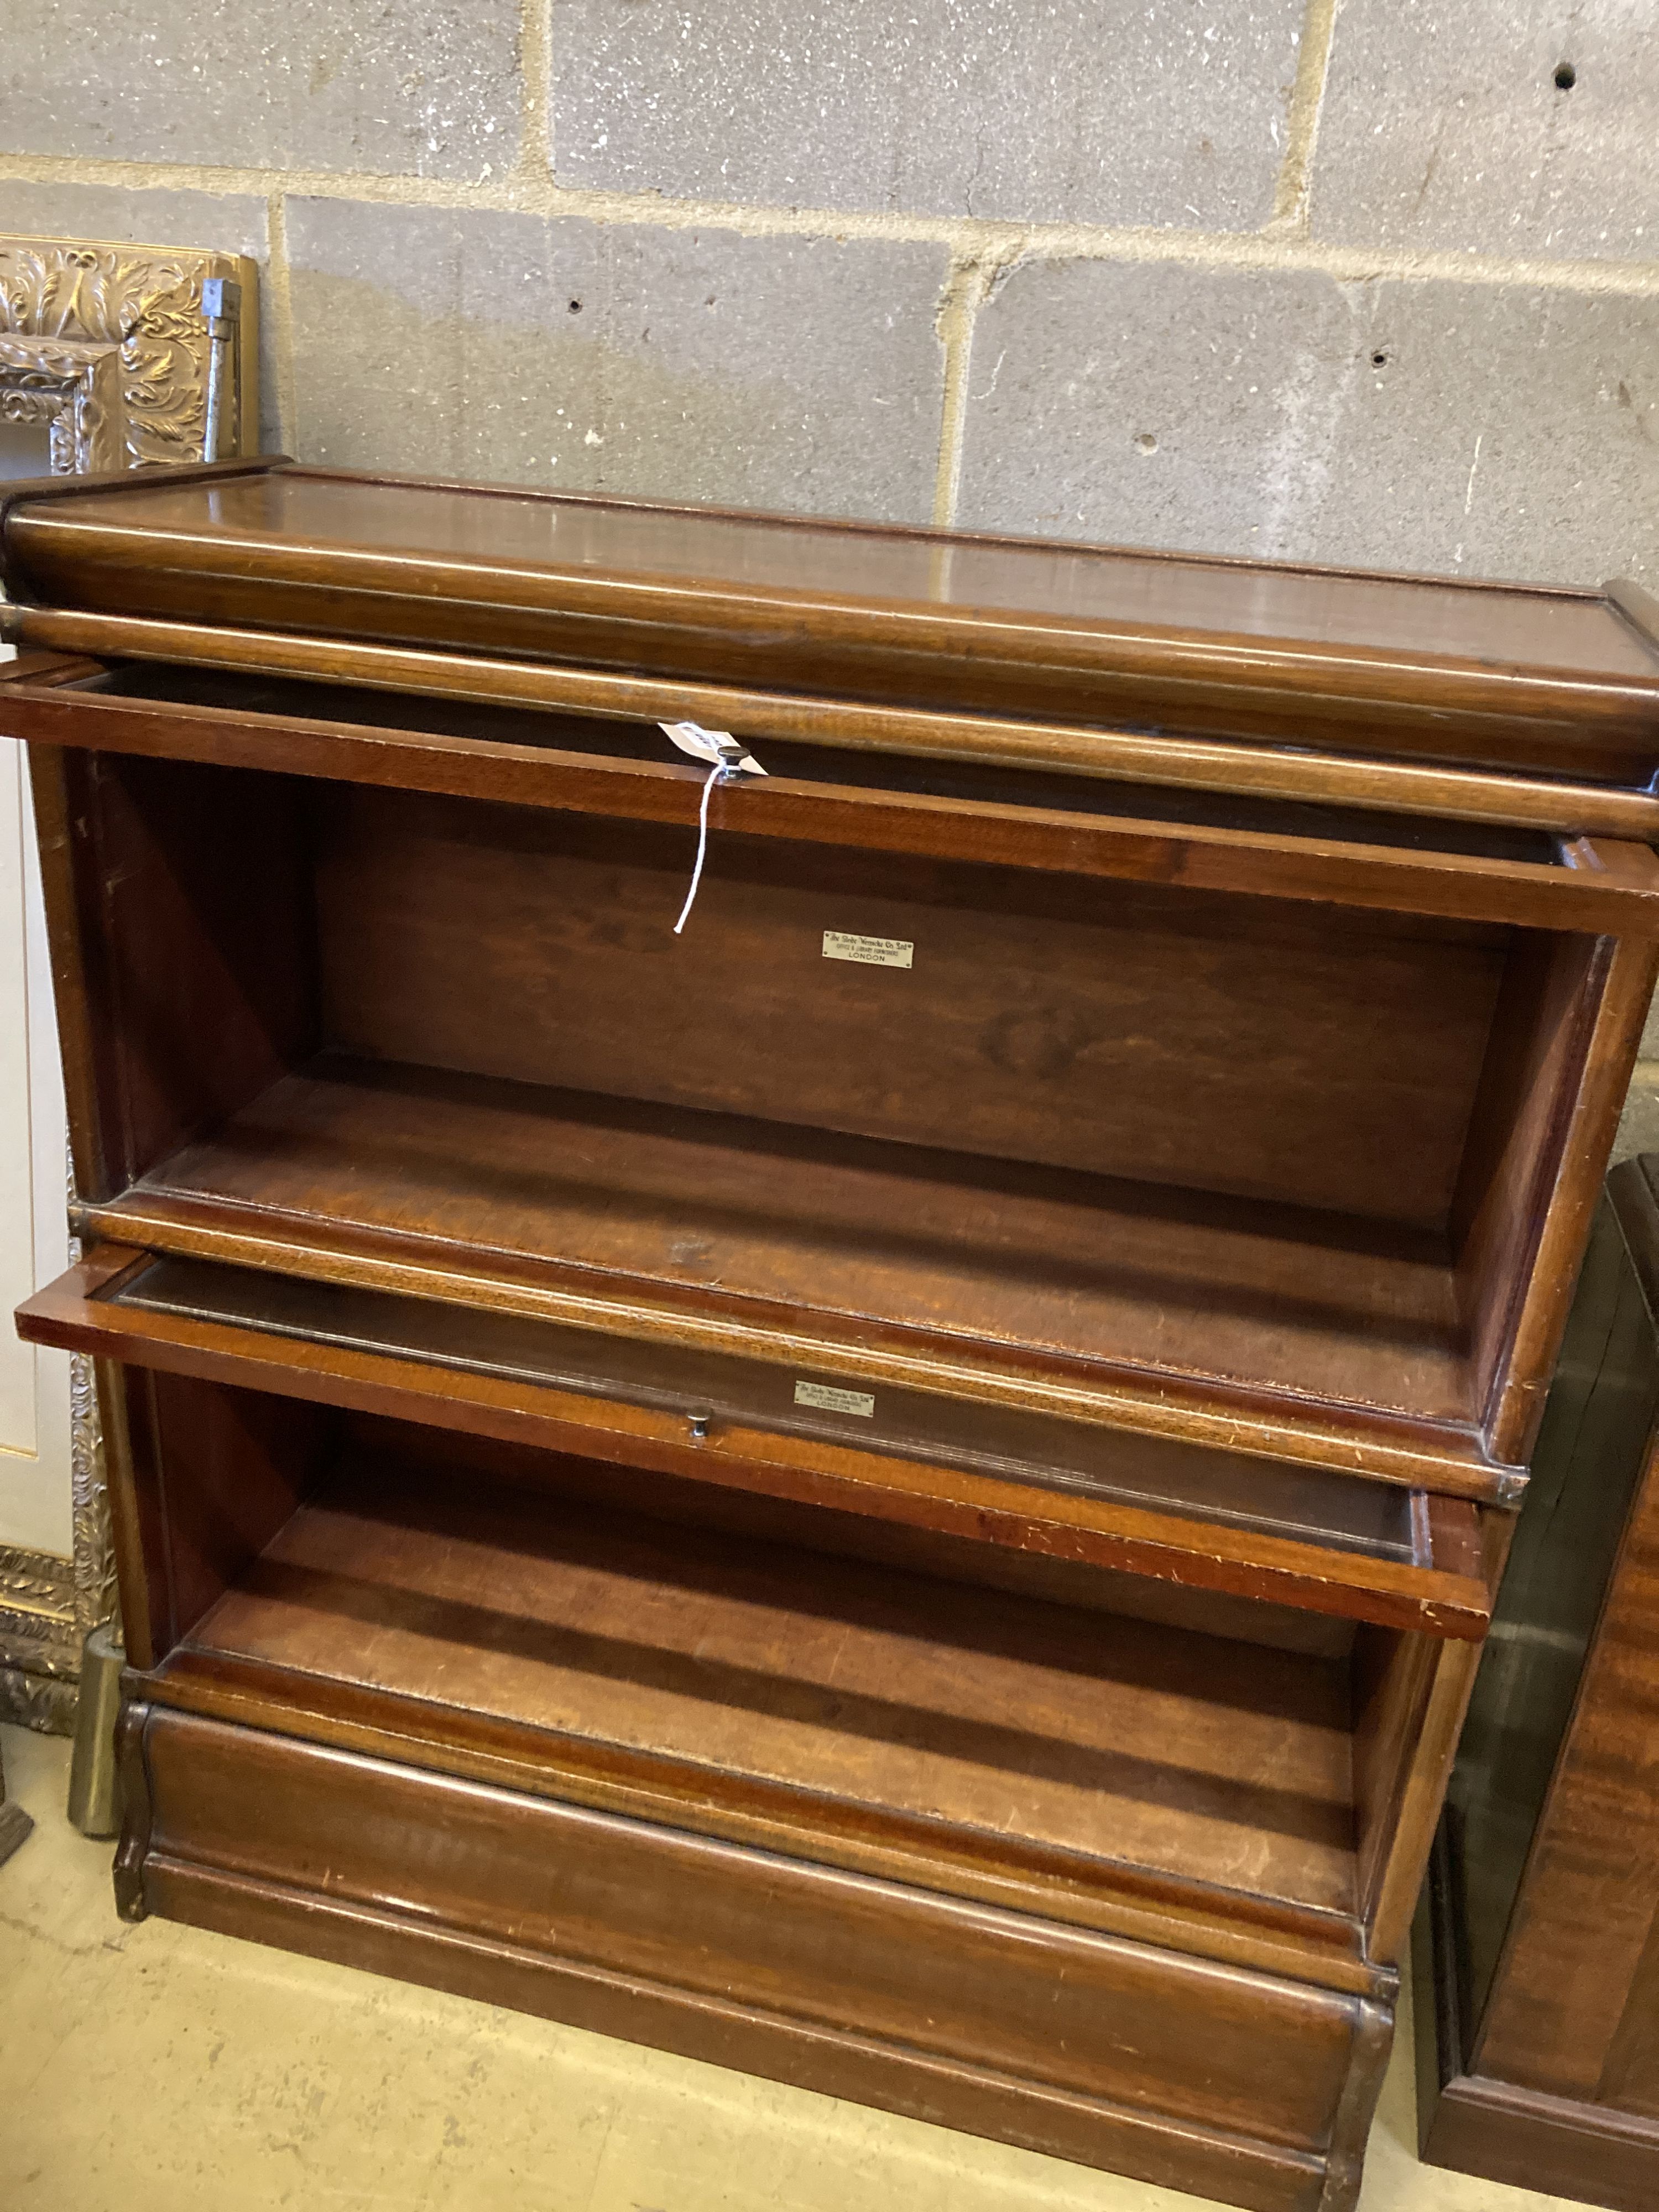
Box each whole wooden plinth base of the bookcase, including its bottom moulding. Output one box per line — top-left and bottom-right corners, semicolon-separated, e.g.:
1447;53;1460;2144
130;1710;1378;2212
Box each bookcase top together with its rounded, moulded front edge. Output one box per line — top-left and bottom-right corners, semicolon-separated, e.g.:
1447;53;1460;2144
0;462;1659;787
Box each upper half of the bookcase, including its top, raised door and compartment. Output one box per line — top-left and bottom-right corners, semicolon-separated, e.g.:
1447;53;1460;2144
2;465;1659;1495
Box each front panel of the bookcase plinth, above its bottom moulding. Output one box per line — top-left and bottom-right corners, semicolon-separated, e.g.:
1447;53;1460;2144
146;1710;1358;2212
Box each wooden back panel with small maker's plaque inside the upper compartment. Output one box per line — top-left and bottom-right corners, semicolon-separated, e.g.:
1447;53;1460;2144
319;790;1502;1230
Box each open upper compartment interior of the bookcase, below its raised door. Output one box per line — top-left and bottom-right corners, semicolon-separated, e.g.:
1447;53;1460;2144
26;726;1641;1486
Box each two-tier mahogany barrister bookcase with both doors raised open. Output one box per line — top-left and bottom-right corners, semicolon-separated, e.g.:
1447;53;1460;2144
0;460;1659;2212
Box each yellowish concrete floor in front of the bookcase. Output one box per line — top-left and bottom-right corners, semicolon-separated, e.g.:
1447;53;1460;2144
0;1728;1593;2212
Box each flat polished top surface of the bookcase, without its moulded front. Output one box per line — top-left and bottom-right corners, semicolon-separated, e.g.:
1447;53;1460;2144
6;465;1659;668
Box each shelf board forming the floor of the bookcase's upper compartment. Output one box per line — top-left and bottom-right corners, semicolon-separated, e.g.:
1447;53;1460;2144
84;1055;1473;1458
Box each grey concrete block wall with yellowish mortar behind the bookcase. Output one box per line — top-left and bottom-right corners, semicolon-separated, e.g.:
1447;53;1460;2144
0;0;1659;1146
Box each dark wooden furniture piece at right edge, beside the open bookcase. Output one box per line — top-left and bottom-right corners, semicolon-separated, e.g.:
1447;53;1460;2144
1416;1155;1659;2212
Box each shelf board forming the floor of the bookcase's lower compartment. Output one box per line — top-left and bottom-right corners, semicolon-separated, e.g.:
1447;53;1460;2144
161;1453;1358;1958
